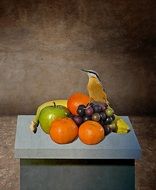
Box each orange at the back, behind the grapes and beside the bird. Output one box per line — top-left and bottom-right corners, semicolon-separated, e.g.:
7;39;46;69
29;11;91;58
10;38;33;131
67;92;90;115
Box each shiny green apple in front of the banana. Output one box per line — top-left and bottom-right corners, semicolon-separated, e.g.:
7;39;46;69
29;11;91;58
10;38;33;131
39;105;69;134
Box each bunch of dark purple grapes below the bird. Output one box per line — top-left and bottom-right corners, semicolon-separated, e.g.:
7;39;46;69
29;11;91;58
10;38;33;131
71;102;115;135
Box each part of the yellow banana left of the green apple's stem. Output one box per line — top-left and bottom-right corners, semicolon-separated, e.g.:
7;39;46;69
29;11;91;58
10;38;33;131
29;101;56;133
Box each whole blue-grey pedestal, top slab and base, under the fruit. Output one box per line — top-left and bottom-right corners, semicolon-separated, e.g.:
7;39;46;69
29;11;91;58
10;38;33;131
15;115;141;190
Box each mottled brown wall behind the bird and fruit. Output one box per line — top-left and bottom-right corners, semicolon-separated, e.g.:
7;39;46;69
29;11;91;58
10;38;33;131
0;0;156;115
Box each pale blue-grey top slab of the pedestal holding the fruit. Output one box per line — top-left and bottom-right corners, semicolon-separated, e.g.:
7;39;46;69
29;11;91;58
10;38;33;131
15;115;141;159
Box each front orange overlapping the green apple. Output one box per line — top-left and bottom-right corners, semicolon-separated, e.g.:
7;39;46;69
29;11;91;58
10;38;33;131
50;117;78;144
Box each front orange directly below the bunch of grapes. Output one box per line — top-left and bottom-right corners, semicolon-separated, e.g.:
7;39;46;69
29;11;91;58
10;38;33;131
79;121;105;145
